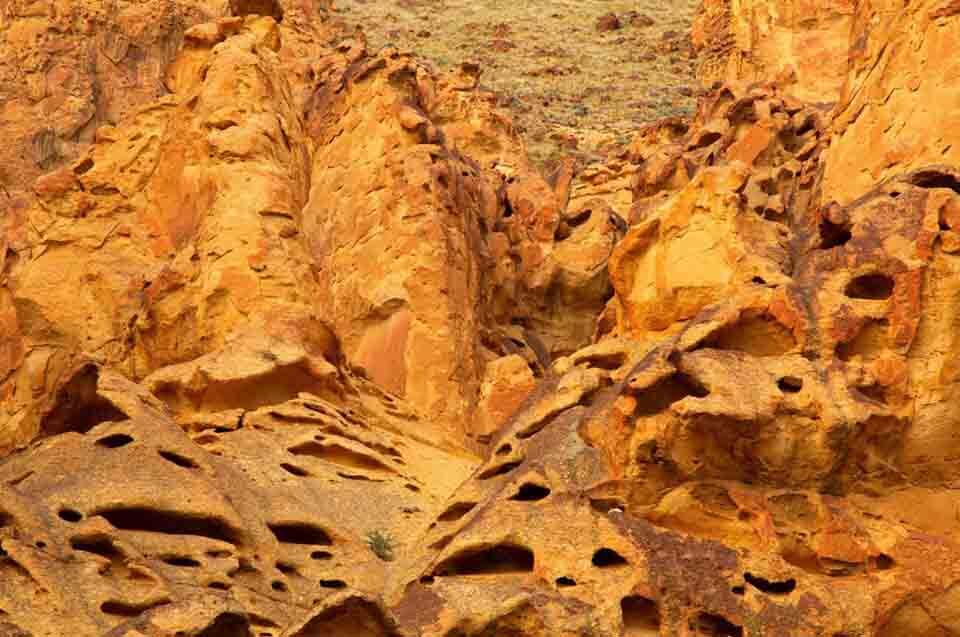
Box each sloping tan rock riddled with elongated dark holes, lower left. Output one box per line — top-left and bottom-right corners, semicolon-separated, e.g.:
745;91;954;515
0;371;474;635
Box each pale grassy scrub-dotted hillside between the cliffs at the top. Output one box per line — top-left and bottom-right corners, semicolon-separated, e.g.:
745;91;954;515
337;0;698;165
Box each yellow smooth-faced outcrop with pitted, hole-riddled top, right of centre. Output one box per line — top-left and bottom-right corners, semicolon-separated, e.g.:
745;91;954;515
601;86;823;351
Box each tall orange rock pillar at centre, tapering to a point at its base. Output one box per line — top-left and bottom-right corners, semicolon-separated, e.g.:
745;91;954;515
302;49;498;439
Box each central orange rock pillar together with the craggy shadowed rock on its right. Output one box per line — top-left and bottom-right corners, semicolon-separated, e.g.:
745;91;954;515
302;50;622;444
